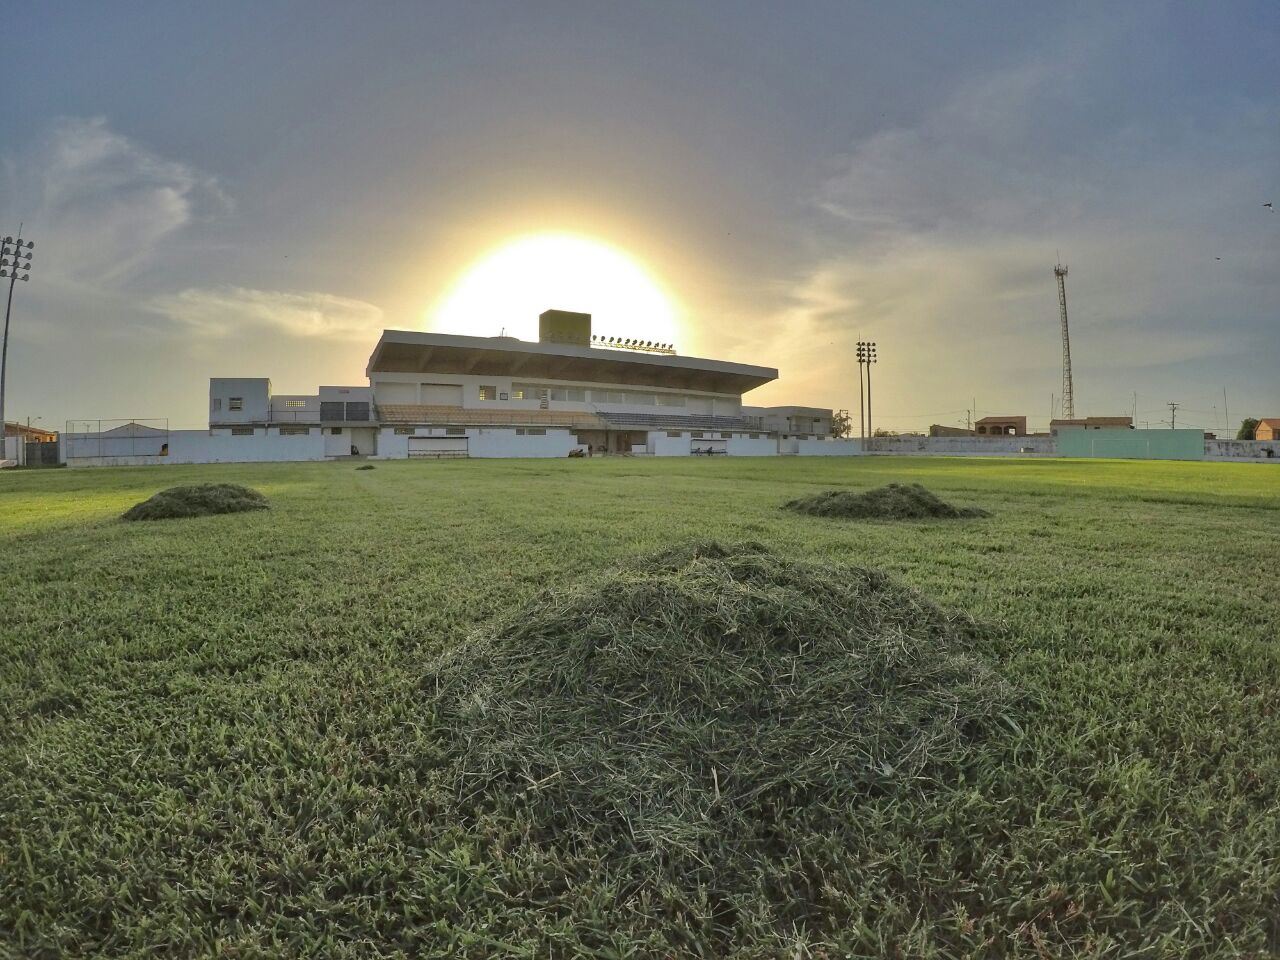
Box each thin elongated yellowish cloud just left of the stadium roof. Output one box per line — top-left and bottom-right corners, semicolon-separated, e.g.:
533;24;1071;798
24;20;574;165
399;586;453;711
147;287;383;340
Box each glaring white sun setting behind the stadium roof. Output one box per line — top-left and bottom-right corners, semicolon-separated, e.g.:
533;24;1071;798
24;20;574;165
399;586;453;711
428;233;678;343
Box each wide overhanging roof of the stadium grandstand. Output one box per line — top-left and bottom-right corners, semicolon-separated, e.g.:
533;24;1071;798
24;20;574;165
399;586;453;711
365;330;778;393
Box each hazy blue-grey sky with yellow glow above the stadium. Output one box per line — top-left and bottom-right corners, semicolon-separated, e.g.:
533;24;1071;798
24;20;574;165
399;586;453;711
0;0;1280;430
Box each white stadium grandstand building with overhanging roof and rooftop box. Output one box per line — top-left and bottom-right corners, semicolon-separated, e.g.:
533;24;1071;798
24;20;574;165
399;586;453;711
197;310;858;458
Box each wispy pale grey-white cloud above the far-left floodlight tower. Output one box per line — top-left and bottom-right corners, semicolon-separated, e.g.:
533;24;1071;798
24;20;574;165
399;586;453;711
6;116;230;287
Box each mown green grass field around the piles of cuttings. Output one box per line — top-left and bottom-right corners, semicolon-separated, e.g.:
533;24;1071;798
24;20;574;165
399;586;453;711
0;458;1280;957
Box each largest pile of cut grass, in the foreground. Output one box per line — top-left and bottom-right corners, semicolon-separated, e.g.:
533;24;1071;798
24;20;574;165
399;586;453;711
422;543;1012;952
